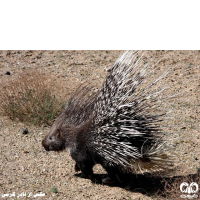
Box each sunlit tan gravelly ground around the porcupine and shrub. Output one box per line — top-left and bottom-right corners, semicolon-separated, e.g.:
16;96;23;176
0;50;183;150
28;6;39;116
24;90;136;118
0;50;200;200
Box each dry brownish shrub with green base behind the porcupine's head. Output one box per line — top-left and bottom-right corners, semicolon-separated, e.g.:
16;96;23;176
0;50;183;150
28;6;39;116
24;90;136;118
0;70;65;125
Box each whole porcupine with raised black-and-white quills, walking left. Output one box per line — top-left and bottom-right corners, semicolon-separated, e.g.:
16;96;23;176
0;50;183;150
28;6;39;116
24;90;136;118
42;51;172;183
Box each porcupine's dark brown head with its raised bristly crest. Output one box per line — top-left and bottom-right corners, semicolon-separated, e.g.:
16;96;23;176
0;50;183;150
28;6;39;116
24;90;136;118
42;87;94;151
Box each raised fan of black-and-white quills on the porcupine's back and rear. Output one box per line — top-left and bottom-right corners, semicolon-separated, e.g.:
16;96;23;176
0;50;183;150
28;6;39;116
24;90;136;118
94;51;174;172
